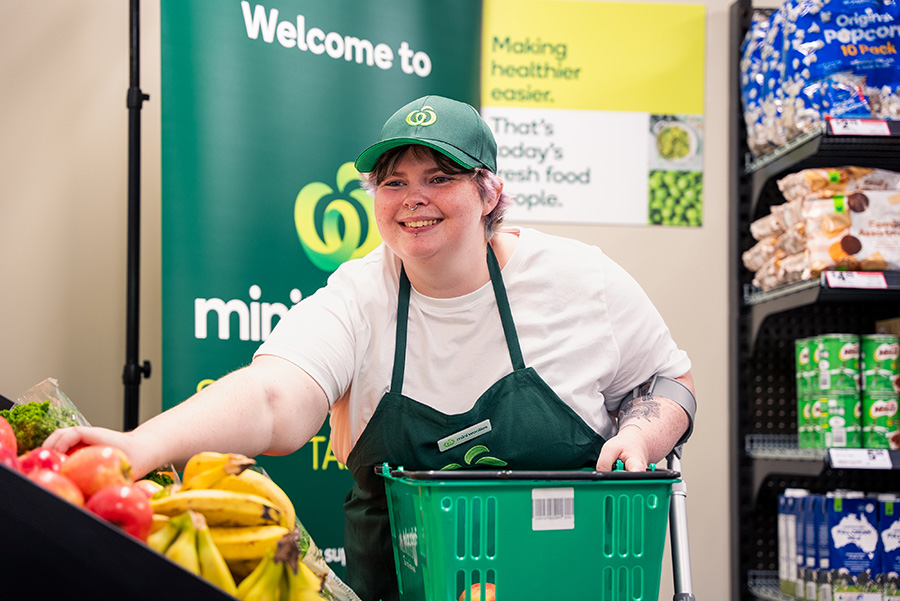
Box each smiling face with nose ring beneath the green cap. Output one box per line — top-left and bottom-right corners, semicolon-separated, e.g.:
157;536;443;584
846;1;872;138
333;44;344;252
375;146;497;273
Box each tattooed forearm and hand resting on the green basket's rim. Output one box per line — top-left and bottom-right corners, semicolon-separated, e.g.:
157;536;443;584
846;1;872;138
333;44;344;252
597;372;694;472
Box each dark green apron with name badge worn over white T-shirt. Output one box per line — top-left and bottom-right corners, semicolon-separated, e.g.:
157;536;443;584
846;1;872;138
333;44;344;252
344;245;604;601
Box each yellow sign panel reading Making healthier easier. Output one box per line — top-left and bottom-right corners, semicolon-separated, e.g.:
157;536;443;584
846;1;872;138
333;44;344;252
482;0;706;114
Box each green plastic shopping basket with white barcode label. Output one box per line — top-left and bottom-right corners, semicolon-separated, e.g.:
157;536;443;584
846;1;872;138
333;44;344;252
376;465;680;601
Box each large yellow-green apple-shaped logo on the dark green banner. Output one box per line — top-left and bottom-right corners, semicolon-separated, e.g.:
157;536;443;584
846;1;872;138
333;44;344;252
294;163;381;272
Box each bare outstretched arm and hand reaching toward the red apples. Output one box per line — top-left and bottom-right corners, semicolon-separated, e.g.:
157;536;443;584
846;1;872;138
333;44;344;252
44;355;328;477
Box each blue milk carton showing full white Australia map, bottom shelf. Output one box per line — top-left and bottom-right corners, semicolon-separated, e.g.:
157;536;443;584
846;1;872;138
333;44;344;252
826;493;881;601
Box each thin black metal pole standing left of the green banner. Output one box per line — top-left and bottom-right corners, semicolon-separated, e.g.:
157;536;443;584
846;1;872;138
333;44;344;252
122;0;150;431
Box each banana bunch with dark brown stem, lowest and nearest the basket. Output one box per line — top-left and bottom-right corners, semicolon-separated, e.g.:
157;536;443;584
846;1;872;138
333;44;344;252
237;532;325;601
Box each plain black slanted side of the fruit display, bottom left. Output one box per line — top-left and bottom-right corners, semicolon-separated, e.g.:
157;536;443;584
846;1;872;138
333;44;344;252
0;465;234;601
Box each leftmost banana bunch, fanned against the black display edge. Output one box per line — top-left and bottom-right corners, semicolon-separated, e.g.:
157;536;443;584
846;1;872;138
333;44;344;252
147;510;237;595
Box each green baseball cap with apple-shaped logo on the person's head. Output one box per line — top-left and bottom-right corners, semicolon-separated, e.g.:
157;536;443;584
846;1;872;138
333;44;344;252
356;96;497;173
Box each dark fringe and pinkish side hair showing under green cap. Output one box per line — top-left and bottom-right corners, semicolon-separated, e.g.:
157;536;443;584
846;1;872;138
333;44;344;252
360;144;509;240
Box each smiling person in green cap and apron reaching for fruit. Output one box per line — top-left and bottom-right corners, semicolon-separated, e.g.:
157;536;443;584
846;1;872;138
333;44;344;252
46;96;694;601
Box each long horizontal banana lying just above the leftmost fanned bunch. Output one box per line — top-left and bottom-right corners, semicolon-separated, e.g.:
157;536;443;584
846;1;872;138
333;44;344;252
150;490;282;527
